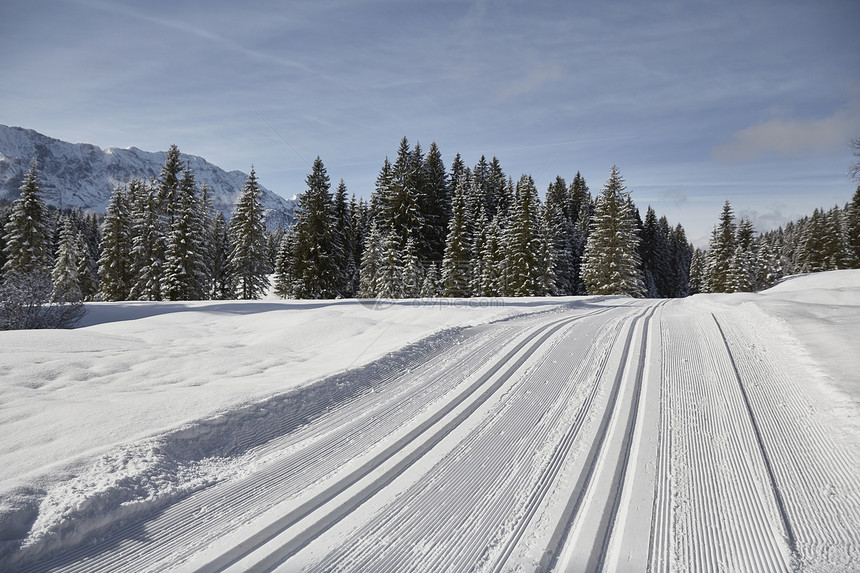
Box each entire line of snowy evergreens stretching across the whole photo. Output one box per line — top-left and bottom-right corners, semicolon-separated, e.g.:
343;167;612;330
0;134;860;327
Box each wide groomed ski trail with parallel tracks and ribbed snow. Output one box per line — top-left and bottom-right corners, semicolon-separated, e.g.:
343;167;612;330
8;298;860;573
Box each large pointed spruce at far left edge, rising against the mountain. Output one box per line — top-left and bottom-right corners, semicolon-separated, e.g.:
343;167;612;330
3;159;53;275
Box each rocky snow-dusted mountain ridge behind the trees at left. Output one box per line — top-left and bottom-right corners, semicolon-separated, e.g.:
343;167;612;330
0;125;295;228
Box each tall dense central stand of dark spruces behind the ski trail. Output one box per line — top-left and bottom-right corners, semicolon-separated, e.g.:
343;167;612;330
274;138;693;298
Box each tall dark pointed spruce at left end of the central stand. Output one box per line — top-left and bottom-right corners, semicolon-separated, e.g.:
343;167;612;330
290;157;344;299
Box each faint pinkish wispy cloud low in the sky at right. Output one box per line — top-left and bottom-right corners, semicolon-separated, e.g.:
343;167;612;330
713;102;860;163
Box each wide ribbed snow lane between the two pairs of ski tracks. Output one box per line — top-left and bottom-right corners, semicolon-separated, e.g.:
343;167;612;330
302;309;640;573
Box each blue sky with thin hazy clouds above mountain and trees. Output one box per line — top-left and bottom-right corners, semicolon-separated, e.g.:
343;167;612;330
0;0;860;243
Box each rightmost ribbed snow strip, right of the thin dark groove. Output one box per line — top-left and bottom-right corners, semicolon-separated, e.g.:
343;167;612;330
721;311;860;571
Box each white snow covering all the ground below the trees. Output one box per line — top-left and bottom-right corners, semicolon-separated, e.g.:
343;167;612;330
0;271;860;570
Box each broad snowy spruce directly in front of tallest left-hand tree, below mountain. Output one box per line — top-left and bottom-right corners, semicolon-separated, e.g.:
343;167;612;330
161;167;209;300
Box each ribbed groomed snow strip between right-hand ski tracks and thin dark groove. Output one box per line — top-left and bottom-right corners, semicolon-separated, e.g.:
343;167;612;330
650;307;791;571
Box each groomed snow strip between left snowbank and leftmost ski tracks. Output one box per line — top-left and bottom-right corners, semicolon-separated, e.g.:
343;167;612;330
13;317;546;572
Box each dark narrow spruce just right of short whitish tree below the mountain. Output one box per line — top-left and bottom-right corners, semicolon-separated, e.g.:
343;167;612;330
99;185;134;301
